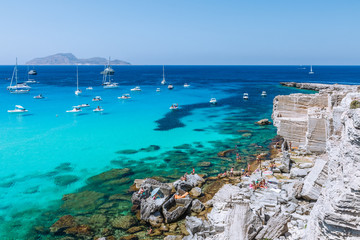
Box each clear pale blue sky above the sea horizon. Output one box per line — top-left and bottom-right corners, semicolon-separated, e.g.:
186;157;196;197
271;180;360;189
0;0;360;65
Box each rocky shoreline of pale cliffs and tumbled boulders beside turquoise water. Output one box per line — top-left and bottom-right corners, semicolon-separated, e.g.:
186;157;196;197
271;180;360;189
38;83;360;240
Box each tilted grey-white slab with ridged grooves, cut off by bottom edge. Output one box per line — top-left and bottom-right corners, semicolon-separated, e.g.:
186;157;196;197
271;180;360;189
255;210;291;239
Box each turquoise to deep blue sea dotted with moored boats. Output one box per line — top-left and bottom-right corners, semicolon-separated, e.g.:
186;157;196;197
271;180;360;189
0;66;360;239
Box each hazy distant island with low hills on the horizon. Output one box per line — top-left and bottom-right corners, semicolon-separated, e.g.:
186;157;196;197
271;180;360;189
26;53;130;65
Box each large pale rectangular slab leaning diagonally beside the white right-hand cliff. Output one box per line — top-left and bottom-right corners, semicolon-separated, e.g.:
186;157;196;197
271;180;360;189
301;159;327;200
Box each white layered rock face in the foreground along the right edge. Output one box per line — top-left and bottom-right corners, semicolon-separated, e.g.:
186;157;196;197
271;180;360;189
307;96;360;240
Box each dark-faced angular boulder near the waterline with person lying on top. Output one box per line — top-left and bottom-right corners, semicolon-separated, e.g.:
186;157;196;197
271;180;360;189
162;196;192;223
